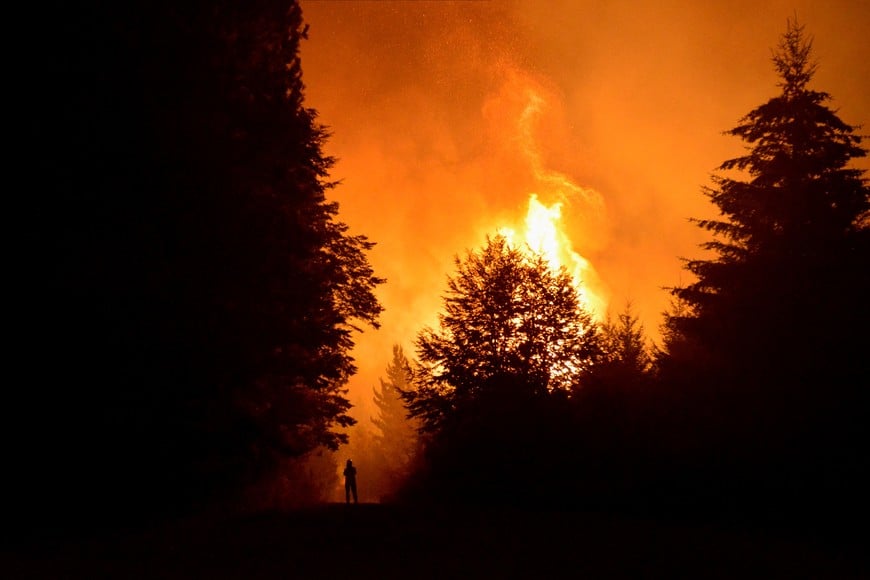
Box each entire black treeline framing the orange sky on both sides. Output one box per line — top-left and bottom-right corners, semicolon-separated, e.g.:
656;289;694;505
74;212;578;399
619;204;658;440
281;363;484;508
11;0;870;522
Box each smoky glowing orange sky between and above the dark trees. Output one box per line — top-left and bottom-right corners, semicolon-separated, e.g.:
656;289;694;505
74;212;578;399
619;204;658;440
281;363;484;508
301;0;870;416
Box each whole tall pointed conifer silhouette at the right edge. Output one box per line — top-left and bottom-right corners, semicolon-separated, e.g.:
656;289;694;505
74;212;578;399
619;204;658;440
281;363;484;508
661;21;870;516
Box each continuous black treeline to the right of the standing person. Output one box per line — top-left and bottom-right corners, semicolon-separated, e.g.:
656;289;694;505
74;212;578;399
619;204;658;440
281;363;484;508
392;20;870;521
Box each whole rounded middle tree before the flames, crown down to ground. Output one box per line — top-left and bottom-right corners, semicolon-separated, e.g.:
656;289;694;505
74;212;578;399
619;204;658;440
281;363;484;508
403;236;600;504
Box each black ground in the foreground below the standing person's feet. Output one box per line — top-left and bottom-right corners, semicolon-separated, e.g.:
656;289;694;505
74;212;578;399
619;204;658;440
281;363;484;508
0;504;870;580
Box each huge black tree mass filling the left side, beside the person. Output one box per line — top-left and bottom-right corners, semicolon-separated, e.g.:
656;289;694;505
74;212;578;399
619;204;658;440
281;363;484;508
13;0;381;524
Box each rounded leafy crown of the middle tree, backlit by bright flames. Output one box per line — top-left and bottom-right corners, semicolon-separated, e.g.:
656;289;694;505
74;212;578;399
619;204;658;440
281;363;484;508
405;236;599;431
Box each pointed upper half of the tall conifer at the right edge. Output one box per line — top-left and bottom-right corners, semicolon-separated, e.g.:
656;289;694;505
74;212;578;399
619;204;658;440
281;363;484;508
690;16;870;270
